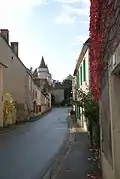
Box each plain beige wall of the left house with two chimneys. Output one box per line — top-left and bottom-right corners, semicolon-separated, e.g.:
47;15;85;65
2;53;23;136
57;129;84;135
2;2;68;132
0;29;29;123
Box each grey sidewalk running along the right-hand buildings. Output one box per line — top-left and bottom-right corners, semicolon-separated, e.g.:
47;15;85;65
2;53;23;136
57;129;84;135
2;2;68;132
56;128;91;179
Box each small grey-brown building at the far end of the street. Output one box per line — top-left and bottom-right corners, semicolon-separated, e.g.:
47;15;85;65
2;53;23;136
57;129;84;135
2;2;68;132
52;82;64;104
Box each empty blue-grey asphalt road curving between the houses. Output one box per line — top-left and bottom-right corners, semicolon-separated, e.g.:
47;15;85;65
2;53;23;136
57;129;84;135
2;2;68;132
0;108;68;179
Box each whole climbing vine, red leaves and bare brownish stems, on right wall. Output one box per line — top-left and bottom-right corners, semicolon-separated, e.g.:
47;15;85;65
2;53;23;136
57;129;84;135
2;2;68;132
90;0;120;101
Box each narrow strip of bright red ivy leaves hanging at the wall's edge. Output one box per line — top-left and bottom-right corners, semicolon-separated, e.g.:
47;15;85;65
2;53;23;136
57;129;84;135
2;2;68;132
90;0;101;100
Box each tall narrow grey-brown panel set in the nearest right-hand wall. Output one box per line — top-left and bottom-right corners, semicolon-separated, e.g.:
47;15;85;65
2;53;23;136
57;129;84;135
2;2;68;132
101;81;113;165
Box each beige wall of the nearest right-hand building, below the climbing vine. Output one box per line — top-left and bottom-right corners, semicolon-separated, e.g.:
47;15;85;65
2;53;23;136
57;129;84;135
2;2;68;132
100;42;120;179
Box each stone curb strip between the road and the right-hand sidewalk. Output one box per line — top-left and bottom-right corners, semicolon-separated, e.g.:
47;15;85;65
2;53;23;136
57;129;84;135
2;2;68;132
40;117;74;179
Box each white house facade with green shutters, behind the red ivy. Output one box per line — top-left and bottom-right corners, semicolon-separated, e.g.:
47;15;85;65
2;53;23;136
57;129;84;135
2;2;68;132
72;39;90;130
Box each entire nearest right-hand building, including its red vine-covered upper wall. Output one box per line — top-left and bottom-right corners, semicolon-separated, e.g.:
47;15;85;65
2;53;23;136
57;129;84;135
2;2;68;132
90;0;120;179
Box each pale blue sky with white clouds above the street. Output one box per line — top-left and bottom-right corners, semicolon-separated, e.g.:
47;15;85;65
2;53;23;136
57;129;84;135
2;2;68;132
0;0;89;80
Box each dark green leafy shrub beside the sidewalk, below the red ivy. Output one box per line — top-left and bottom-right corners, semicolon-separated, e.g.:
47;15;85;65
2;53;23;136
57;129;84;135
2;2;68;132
75;90;100;148
